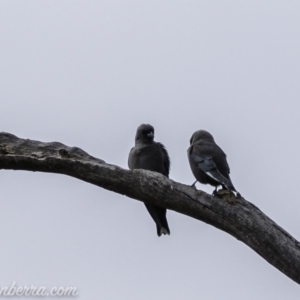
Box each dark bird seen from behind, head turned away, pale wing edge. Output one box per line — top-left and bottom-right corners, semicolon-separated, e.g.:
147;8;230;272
188;130;239;195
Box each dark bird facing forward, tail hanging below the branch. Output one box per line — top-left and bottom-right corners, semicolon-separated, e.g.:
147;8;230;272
128;124;170;236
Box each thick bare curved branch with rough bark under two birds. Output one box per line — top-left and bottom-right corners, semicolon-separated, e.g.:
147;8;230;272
0;133;300;283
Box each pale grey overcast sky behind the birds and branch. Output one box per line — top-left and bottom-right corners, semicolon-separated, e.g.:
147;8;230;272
0;0;300;300
